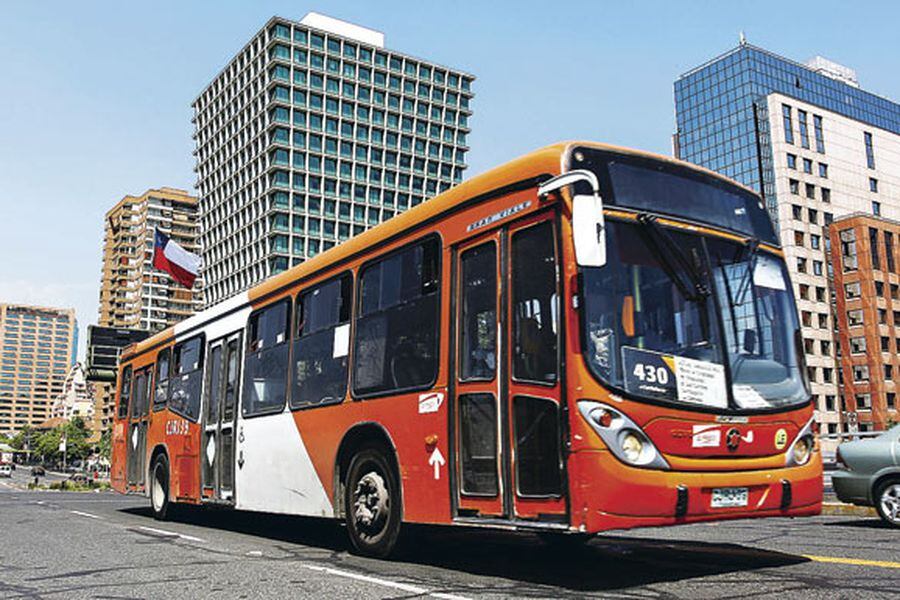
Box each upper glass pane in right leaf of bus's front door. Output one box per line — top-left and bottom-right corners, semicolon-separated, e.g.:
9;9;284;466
512;221;558;383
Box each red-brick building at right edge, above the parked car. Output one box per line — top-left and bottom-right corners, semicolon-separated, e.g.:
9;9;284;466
829;213;900;431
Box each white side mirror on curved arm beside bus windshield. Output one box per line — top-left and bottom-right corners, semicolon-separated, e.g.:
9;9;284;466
538;169;606;267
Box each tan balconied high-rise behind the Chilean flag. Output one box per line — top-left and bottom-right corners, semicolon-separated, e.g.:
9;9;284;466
98;187;203;331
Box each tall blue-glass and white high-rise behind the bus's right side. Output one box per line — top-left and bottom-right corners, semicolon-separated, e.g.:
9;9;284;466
673;42;900;434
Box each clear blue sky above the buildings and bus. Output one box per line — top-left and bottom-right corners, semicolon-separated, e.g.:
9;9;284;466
0;0;900;356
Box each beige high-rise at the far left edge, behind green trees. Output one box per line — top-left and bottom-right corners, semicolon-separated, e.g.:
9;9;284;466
0;303;78;433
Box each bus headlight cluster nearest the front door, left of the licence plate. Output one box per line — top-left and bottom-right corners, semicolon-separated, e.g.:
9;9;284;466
578;400;669;469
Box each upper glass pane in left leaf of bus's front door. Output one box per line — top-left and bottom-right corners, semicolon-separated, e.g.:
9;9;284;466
459;243;497;381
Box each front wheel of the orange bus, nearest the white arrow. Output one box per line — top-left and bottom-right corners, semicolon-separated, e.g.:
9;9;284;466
344;446;401;558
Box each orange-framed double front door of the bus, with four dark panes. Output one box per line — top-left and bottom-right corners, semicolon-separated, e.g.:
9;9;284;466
453;216;567;523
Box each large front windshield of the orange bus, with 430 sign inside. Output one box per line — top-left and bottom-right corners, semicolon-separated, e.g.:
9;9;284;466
582;218;808;410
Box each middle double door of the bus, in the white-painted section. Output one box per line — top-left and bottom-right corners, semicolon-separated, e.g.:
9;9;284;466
200;333;241;504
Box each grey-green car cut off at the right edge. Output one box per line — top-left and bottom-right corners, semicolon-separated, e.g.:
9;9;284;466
831;425;900;527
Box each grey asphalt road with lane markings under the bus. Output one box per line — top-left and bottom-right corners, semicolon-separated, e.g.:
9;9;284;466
0;471;900;600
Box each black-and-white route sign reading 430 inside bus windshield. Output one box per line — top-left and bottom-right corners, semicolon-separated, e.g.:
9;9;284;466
622;346;728;408
